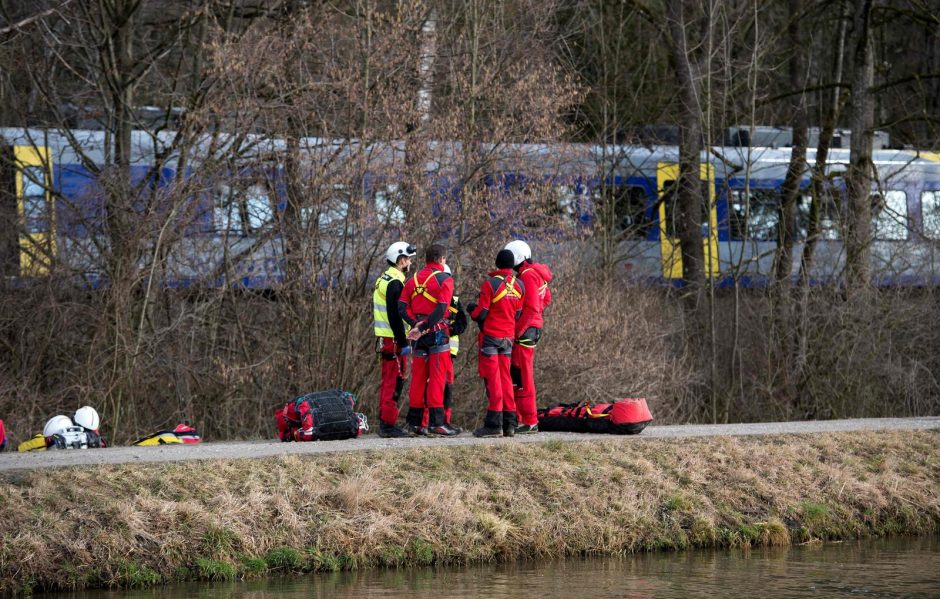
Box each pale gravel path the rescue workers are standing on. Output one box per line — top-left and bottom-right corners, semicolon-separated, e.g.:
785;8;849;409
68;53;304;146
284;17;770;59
0;417;940;472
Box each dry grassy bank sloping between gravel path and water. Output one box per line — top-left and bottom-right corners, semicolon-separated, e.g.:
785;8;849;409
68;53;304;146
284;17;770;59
0;431;940;592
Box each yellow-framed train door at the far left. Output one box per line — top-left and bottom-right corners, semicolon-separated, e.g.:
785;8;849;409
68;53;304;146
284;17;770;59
13;146;56;277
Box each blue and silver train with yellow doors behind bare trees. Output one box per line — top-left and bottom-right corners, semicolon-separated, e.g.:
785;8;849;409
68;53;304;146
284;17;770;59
0;128;940;289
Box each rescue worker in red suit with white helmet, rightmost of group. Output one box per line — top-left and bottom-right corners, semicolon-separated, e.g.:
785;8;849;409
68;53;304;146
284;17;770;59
506;240;552;435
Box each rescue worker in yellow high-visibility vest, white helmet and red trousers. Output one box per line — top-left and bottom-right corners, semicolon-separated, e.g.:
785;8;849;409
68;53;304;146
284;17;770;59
372;241;416;437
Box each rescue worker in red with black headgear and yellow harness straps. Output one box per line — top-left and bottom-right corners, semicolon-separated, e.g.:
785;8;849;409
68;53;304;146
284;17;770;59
467;249;525;437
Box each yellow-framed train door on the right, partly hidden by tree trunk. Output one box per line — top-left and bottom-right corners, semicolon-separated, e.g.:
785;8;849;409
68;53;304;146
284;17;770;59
656;162;719;279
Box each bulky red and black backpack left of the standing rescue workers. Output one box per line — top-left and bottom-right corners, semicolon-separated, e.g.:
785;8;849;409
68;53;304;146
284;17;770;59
274;389;368;442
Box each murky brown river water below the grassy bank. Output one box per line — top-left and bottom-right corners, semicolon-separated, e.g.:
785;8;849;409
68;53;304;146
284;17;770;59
53;537;940;599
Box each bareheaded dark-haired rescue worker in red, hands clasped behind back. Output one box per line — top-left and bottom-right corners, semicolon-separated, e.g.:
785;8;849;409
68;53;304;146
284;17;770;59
398;244;458;437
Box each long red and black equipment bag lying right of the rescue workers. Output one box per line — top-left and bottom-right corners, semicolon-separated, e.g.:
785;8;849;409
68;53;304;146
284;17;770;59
538;398;653;435
